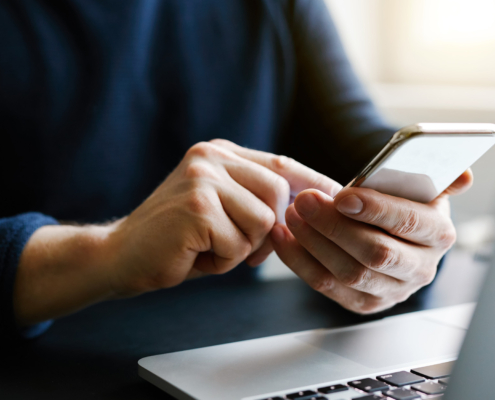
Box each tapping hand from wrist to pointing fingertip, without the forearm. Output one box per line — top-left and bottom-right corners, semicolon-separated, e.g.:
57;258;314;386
108;140;340;296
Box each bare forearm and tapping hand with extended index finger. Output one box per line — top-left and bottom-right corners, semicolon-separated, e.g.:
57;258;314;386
14;140;341;325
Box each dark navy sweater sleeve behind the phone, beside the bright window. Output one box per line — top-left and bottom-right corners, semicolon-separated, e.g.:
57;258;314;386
280;0;395;185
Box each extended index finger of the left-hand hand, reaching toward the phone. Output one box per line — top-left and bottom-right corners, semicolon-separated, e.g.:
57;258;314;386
211;139;342;197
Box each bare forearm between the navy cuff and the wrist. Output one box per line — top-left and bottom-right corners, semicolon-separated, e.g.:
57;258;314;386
13;225;117;327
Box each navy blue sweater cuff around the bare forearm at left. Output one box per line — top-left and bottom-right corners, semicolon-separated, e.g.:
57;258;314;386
0;213;58;343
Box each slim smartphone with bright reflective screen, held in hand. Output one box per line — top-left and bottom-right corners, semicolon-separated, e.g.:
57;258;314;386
347;123;495;203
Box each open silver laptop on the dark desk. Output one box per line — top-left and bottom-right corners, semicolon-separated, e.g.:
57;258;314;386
139;256;495;400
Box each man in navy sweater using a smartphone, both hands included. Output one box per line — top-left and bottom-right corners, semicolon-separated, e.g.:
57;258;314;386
0;0;472;337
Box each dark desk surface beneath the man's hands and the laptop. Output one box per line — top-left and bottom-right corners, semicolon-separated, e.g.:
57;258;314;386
0;252;485;400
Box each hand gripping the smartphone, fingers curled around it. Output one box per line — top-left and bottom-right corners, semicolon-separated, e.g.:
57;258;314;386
271;170;472;314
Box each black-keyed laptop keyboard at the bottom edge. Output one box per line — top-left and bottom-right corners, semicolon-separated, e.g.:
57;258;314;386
259;361;454;400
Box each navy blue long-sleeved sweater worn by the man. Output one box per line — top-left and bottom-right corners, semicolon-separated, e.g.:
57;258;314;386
0;0;392;336
